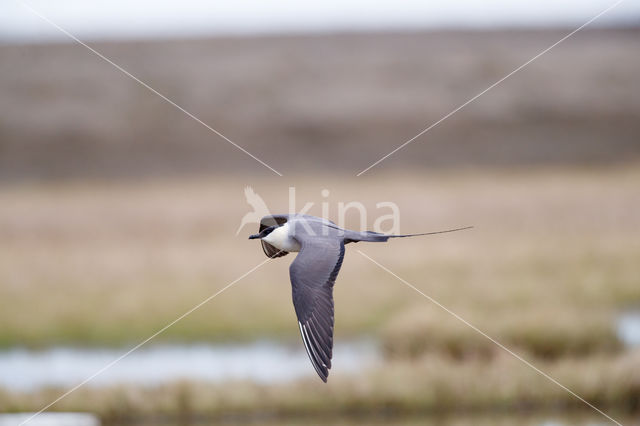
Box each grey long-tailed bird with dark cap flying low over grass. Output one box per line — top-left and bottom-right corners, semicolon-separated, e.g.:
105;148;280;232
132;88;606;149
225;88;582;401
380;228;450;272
249;214;471;382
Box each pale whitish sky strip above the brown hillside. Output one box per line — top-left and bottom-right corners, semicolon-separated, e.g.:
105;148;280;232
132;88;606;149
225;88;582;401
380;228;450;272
0;0;640;42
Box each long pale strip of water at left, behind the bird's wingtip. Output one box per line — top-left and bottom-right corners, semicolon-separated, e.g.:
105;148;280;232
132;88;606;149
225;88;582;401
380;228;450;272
0;340;379;390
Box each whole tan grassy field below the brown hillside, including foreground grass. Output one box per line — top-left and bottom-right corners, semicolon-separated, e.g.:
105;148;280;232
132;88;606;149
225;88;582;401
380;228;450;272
0;164;640;421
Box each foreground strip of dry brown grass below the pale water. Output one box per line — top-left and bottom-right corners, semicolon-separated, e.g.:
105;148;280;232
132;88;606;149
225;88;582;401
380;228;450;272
0;352;640;424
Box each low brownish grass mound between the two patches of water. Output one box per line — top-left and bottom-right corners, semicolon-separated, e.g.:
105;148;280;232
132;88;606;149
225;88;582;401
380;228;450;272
383;306;622;359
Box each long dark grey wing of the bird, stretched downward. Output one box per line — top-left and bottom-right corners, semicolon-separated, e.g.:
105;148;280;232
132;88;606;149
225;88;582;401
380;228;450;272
289;235;344;382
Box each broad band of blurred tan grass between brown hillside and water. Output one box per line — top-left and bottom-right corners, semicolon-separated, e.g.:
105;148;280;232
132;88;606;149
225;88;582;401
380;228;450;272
0;167;640;355
